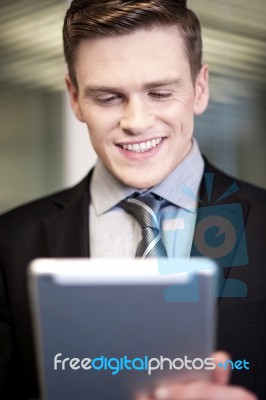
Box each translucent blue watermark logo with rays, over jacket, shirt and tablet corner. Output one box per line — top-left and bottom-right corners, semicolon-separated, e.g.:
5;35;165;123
158;173;249;302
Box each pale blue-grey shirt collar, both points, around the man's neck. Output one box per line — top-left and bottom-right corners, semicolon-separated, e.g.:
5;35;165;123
91;139;204;215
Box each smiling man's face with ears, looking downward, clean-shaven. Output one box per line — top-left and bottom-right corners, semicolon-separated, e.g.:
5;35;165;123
66;26;208;189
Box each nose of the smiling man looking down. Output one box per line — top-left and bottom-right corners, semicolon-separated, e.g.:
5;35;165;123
120;98;153;135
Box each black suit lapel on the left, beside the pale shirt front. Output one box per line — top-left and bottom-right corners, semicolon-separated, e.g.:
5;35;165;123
44;173;91;257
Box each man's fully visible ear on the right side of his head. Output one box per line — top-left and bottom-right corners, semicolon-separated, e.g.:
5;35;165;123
194;65;209;115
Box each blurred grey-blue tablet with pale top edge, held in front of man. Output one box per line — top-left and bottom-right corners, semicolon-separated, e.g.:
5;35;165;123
29;258;217;400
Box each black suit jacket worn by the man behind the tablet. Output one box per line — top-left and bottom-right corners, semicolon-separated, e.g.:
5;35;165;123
0;161;266;399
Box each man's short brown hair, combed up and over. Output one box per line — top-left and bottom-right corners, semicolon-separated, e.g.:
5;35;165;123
63;0;202;87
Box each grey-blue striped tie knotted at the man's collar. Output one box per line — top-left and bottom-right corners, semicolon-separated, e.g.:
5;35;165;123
119;194;167;258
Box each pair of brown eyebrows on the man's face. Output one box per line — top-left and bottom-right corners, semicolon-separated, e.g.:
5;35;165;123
84;78;184;97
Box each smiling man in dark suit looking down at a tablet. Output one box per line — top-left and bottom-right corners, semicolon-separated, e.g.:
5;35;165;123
0;0;266;400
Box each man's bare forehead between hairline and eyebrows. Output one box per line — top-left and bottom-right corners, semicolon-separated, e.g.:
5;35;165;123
75;25;190;84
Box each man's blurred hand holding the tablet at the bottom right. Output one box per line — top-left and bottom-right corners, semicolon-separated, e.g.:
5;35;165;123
136;352;258;400
